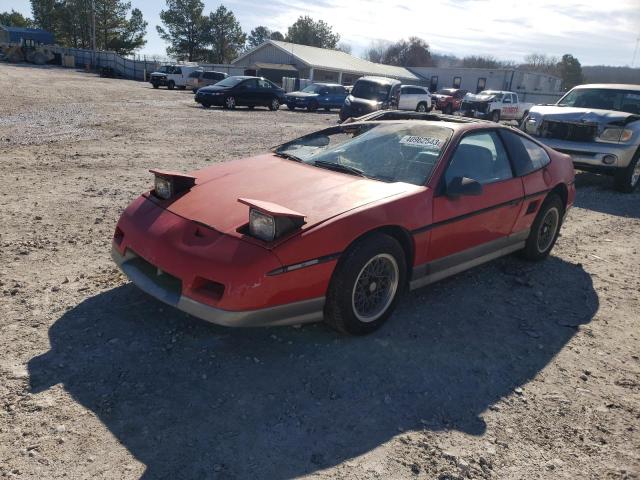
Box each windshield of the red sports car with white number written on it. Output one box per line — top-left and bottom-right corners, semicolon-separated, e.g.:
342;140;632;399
274;122;453;185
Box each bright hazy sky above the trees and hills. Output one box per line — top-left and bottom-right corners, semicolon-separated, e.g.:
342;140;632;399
7;0;640;67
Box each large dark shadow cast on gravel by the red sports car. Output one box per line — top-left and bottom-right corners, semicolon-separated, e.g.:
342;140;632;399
28;258;598;480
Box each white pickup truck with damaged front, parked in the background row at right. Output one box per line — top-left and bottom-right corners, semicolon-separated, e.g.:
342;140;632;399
456;90;533;122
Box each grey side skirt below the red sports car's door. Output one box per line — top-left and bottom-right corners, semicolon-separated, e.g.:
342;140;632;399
409;229;529;290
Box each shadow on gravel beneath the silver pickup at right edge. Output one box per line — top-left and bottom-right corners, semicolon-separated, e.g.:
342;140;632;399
574;172;640;218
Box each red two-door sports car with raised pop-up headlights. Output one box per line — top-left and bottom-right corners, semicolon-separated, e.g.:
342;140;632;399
113;111;575;334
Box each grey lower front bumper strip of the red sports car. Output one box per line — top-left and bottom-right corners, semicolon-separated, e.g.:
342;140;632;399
111;246;325;327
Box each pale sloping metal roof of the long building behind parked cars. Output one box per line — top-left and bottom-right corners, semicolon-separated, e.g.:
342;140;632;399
232;40;420;80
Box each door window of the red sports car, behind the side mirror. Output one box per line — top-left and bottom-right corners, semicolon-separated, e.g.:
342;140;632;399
444;132;513;185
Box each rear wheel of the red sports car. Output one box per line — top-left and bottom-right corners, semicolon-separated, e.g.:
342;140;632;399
521;193;565;261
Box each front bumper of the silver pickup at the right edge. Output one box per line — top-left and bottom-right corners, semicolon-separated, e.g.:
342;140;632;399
534;136;638;171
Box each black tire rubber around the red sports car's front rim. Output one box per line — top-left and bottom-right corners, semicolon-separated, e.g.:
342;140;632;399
324;233;407;335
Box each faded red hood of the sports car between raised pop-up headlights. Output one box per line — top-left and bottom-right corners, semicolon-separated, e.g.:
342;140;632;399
156;154;423;236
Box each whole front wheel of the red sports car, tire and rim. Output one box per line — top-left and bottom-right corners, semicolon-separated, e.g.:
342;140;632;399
324;234;407;335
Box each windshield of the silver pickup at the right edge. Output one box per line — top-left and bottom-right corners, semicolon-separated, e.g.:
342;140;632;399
558;88;640;115
